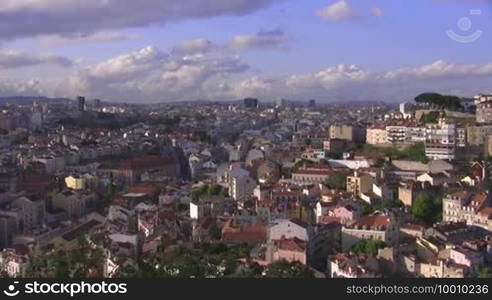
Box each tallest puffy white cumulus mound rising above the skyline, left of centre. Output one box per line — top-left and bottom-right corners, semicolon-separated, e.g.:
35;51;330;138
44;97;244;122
67;43;249;101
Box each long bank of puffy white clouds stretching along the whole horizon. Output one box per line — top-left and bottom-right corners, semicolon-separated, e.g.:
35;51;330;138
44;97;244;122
0;39;492;102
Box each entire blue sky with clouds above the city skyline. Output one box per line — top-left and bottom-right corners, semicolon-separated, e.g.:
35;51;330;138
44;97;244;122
0;0;492;103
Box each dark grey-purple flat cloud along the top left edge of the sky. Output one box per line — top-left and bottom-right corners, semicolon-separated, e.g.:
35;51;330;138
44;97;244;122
0;0;283;40
